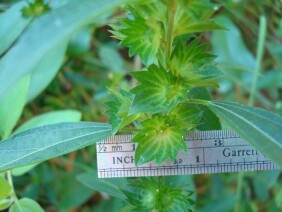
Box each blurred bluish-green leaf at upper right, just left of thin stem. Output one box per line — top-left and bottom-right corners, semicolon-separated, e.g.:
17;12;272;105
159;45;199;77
211;16;256;88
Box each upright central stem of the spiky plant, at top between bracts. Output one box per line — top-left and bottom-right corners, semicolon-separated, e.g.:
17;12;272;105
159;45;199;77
165;0;177;67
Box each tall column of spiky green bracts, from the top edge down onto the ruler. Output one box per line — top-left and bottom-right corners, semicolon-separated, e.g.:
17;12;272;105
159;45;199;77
108;0;224;165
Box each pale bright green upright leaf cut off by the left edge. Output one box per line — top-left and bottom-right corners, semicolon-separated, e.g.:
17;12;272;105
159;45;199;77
0;76;30;138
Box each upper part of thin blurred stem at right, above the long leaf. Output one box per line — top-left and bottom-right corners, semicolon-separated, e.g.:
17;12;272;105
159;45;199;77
249;16;267;106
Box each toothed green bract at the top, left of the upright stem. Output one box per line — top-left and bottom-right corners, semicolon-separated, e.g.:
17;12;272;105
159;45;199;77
111;1;165;64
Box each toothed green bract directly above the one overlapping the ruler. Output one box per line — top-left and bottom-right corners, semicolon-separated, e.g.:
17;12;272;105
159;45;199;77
129;64;189;114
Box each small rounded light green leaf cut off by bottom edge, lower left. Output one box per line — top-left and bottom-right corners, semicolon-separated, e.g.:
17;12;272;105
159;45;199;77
9;198;44;212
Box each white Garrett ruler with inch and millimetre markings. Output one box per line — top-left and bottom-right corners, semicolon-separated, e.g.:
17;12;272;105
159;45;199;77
97;130;278;178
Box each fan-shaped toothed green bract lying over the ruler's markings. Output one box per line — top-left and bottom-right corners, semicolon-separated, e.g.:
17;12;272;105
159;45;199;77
132;115;187;166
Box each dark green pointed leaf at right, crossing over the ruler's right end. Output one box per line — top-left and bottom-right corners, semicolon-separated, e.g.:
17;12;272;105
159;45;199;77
209;101;282;167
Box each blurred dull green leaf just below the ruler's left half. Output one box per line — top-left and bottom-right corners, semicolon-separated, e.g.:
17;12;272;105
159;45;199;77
77;172;127;199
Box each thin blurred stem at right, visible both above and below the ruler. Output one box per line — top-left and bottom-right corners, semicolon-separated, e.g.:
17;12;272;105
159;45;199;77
235;16;267;212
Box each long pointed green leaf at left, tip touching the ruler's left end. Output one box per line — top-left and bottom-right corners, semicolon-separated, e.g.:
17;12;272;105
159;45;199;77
0;122;112;171
